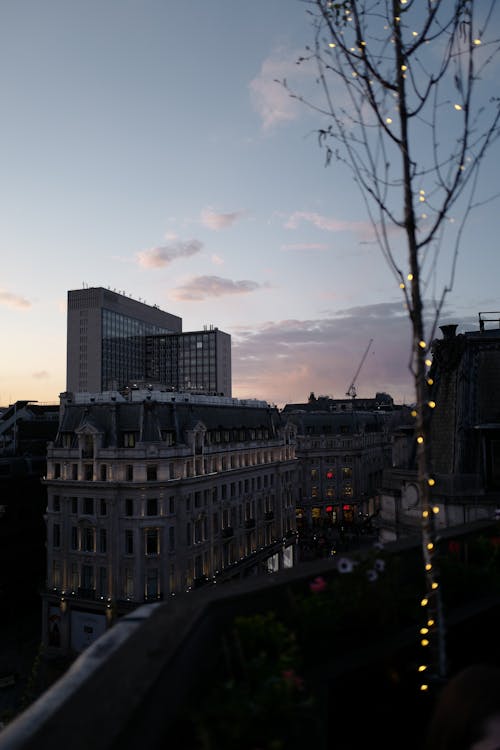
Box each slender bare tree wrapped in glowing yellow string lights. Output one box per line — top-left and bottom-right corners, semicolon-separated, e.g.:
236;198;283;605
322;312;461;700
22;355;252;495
281;0;500;690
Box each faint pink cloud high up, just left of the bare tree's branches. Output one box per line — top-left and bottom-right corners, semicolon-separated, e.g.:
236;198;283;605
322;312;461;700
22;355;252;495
249;48;312;130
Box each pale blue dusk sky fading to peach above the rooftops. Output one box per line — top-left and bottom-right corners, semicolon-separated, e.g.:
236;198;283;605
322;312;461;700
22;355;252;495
0;0;500;406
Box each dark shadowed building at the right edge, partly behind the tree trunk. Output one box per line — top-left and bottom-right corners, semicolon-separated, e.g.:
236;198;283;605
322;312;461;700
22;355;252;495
379;313;500;541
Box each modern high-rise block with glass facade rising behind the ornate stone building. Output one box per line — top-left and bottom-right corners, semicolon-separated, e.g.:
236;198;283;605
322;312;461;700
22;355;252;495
66;287;231;396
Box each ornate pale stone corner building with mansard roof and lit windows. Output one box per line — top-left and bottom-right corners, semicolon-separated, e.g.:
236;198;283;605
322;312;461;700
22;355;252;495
43;390;297;652
